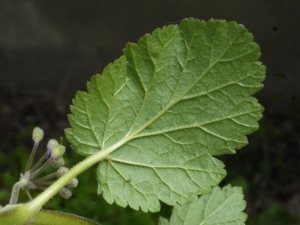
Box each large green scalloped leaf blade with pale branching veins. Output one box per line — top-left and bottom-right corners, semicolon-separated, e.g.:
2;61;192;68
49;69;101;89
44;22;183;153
66;19;265;211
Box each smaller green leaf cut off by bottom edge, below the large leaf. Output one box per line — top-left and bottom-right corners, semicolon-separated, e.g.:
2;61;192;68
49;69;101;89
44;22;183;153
160;185;247;225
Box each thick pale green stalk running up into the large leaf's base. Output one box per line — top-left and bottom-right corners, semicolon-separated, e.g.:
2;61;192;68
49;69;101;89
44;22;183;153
26;137;130;211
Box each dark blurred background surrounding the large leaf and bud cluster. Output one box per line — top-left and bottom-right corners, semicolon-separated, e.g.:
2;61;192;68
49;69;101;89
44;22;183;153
0;0;300;225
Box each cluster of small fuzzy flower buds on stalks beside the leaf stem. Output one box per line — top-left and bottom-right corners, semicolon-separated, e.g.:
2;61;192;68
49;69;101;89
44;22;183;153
10;127;78;204
